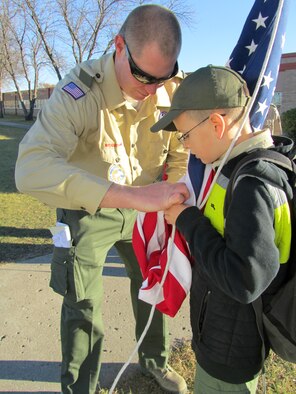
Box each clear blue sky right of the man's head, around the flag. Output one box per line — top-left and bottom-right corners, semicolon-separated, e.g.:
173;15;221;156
179;0;296;71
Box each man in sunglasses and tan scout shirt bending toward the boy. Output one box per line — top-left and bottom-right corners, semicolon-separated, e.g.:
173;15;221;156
16;5;188;394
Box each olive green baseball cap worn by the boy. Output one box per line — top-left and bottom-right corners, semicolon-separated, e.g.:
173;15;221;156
151;64;250;133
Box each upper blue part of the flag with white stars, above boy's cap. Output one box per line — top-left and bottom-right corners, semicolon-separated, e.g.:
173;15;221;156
226;0;290;130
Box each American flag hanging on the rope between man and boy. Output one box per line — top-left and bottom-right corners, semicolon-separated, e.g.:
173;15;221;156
133;0;291;316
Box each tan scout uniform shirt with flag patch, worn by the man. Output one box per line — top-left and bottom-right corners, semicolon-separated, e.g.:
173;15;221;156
16;54;188;214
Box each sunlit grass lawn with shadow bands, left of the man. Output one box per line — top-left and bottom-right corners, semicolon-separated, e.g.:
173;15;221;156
0;118;55;263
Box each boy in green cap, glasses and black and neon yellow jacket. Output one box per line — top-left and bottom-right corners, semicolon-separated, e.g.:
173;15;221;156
151;66;292;394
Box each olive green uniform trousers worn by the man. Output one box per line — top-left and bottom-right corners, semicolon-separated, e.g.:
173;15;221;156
50;209;169;394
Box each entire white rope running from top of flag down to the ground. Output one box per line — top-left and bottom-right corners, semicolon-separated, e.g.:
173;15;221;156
109;0;284;394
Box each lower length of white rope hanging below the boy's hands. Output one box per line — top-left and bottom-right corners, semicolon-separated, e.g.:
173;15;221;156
109;226;176;394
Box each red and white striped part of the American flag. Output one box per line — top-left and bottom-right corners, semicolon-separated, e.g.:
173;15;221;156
133;165;212;317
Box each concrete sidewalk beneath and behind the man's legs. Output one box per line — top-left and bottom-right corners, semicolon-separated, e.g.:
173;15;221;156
0;250;191;394
